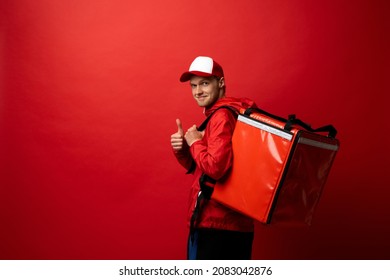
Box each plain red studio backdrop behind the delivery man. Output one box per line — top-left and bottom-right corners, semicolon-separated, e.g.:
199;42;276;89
0;0;390;259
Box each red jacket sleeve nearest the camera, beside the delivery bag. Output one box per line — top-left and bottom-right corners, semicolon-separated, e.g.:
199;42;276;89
190;109;236;180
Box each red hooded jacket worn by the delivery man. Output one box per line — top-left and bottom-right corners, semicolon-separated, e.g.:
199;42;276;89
175;97;256;232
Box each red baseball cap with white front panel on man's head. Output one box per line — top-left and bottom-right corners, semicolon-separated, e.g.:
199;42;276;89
180;56;224;82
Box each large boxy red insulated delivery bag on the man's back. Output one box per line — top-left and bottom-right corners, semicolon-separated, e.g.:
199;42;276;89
201;108;339;225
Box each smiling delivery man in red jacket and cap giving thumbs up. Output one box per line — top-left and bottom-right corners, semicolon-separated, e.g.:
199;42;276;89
171;56;256;259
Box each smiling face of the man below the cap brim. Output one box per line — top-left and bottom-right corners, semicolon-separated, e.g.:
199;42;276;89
190;76;224;108
